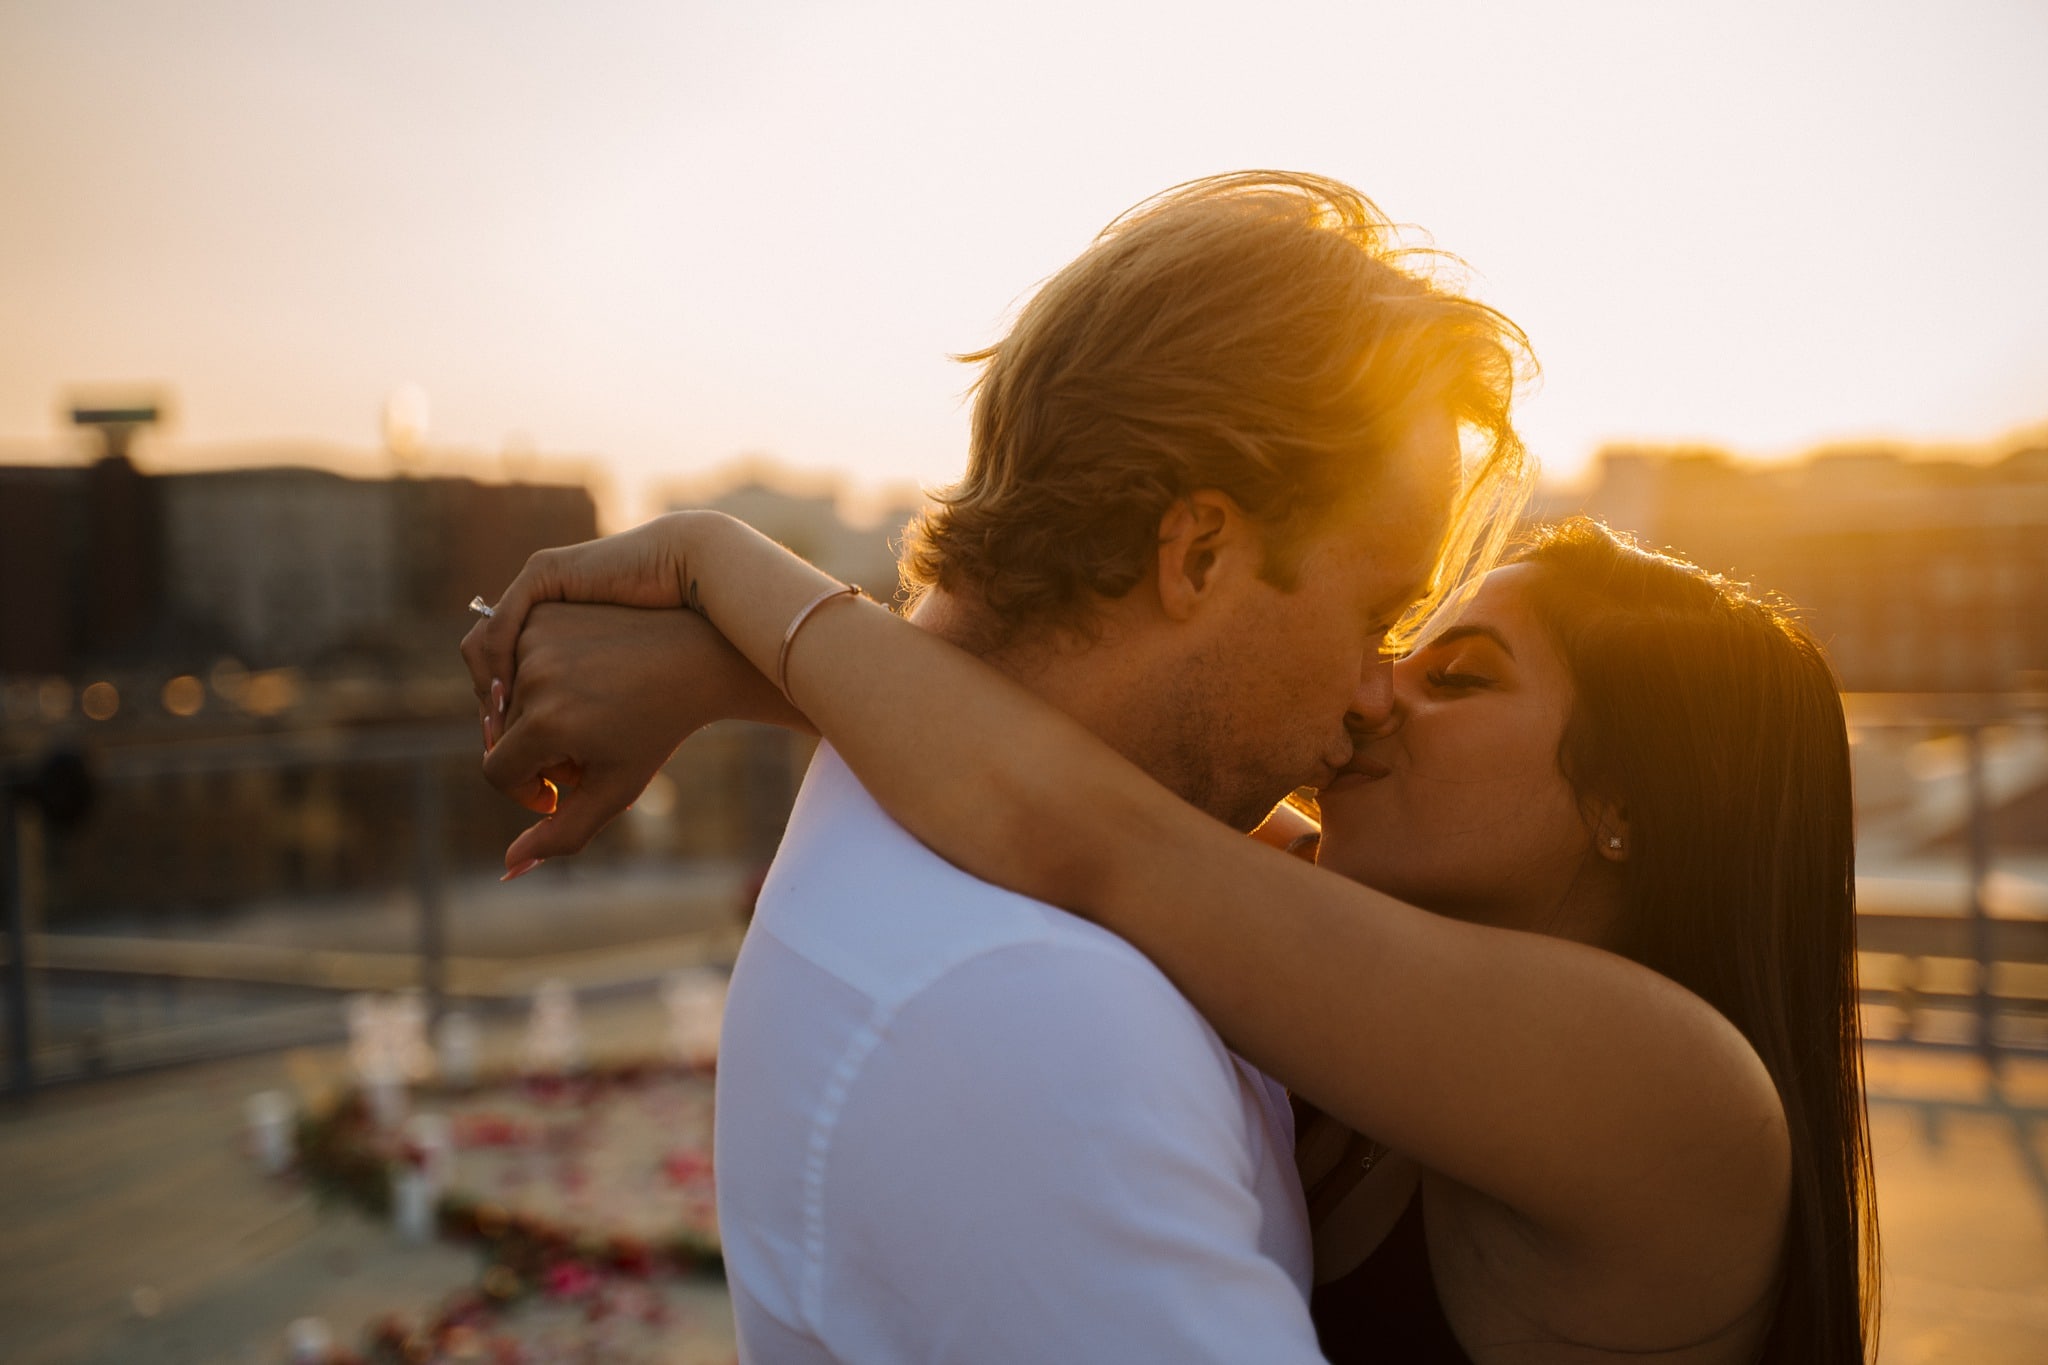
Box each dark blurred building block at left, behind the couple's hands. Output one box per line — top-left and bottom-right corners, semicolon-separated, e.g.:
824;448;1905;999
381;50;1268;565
0;435;598;675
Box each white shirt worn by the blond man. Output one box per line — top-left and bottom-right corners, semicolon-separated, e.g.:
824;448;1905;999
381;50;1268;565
715;749;1323;1365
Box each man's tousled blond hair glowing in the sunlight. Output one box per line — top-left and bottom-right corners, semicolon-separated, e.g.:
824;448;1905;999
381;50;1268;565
903;170;1530;639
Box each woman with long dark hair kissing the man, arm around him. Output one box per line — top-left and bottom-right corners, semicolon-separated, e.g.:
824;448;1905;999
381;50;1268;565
471;514;1876;1365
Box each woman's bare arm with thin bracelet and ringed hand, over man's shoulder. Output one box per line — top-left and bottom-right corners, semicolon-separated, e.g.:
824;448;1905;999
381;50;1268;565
465;514;1788;1265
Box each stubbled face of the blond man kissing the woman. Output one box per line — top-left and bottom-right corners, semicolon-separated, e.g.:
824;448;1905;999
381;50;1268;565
1159;415;1458;829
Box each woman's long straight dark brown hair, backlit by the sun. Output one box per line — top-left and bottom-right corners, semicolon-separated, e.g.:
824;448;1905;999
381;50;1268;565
1518;518;1878;1365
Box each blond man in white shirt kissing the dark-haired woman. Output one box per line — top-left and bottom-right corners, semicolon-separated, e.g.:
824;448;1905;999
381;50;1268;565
465;172;1526;1365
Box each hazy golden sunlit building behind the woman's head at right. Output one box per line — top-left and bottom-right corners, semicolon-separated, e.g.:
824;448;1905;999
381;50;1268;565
1534;437;2048;692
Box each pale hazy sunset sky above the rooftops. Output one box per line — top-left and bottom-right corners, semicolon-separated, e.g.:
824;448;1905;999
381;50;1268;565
0;0;2048;512
